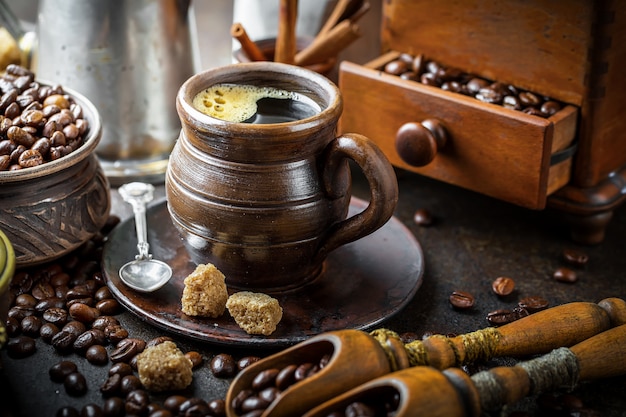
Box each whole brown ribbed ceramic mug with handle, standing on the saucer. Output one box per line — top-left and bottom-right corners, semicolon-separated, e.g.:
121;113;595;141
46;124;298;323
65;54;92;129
165;62;398;292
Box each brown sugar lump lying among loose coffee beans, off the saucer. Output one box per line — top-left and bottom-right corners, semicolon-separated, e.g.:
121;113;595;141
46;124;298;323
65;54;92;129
137;341;193;392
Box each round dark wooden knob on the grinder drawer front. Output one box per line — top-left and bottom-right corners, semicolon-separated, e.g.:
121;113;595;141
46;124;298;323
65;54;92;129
396;119;448;167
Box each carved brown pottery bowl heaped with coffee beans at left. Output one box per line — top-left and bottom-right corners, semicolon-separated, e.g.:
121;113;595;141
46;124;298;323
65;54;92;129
0;65;111;268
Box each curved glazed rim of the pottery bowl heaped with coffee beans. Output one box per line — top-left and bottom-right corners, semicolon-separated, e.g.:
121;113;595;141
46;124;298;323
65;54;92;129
0;79;102;184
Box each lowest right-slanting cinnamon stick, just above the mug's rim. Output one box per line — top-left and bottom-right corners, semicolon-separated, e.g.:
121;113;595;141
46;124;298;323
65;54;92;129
295;20;361;66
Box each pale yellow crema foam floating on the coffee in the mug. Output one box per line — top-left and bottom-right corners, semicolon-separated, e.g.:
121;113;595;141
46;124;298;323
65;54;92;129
192;84;303;123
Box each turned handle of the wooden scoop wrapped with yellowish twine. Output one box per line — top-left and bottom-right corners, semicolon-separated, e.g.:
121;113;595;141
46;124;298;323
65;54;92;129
406;298;626;369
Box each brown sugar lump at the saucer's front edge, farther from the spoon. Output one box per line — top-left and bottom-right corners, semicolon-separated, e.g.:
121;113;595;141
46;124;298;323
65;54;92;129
226;291;283;336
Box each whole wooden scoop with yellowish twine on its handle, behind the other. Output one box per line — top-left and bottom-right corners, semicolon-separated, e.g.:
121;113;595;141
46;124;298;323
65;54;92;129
226;298;626;417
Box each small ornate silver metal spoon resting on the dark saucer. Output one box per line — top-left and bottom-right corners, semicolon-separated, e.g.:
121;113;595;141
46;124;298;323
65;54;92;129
119;182;172;292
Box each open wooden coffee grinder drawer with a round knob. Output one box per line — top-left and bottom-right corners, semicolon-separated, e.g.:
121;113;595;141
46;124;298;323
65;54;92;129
339;57;578;209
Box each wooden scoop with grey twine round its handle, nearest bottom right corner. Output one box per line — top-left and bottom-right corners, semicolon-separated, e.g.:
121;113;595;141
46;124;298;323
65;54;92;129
304;325;626;417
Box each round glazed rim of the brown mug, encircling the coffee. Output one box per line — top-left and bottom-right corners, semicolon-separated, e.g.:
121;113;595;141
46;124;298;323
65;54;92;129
176;61;343;132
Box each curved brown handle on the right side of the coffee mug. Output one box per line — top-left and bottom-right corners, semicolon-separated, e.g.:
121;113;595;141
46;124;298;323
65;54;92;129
317;133;398;259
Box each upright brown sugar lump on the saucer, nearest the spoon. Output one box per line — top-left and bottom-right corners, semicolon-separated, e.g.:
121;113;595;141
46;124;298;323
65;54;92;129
181;264;228;318
